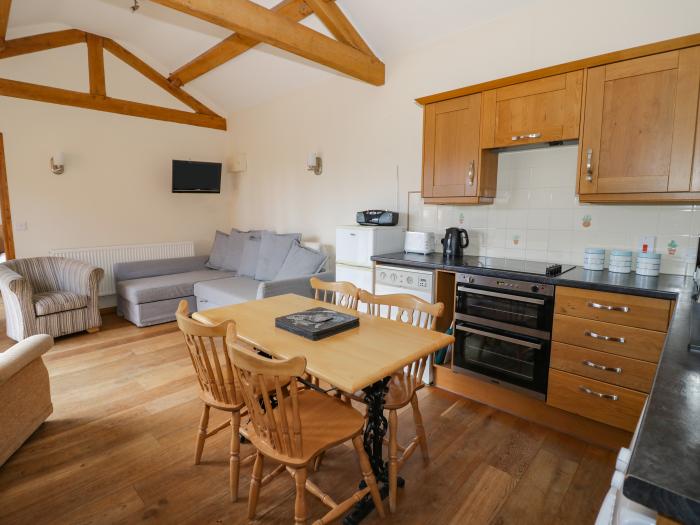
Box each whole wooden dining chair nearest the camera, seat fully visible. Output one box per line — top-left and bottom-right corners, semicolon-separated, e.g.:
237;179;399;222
226;326;384;525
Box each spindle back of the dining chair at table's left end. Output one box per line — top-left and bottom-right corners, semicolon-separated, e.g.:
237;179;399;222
175;300;243;408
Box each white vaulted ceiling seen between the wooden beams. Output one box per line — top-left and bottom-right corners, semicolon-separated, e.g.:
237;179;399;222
2;0;536;113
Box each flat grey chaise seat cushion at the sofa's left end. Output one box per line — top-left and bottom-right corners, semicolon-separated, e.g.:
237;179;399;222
117;270;234;304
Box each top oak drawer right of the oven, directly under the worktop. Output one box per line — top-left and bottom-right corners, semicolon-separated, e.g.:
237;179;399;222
554;286;671;332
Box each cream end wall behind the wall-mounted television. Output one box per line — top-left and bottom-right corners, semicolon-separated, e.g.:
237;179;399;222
0;37;231;257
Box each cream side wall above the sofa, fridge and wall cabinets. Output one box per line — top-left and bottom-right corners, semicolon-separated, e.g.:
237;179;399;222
228;0;700;258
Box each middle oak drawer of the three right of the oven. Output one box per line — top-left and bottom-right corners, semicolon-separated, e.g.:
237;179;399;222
552;314;666;363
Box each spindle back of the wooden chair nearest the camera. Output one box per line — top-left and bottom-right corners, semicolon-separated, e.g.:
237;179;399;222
226;326;306;458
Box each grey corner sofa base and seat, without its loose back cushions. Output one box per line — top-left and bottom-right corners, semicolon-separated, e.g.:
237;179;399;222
114;238;335;326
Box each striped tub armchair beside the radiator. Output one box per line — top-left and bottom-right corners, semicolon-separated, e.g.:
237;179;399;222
0;257;104;341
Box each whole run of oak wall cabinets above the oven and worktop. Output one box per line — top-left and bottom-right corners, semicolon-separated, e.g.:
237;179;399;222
417;34;700;204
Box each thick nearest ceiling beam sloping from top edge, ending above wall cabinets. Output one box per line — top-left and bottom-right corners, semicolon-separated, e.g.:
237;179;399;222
153;0;385;86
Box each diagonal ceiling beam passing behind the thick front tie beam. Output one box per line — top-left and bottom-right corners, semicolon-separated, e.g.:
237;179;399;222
168;0;314;86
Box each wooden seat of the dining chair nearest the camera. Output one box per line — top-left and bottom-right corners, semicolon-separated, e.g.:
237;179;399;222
243;390;365;466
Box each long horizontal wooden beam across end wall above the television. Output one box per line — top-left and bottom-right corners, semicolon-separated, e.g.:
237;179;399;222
0;78;226;130
